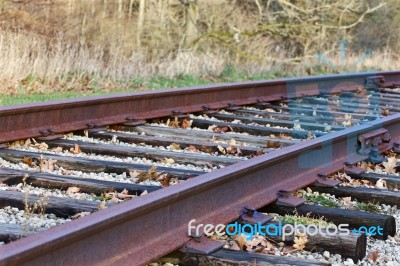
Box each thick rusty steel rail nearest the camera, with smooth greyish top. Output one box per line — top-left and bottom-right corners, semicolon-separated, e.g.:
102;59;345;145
0;114;400;265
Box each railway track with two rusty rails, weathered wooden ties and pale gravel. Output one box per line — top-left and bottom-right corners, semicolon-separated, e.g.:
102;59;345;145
0;72;400;265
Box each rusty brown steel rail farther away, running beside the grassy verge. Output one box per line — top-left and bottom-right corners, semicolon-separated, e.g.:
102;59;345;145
0;71;400;143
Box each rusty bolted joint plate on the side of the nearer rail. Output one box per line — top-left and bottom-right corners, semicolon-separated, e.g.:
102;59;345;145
358;128;391;163
